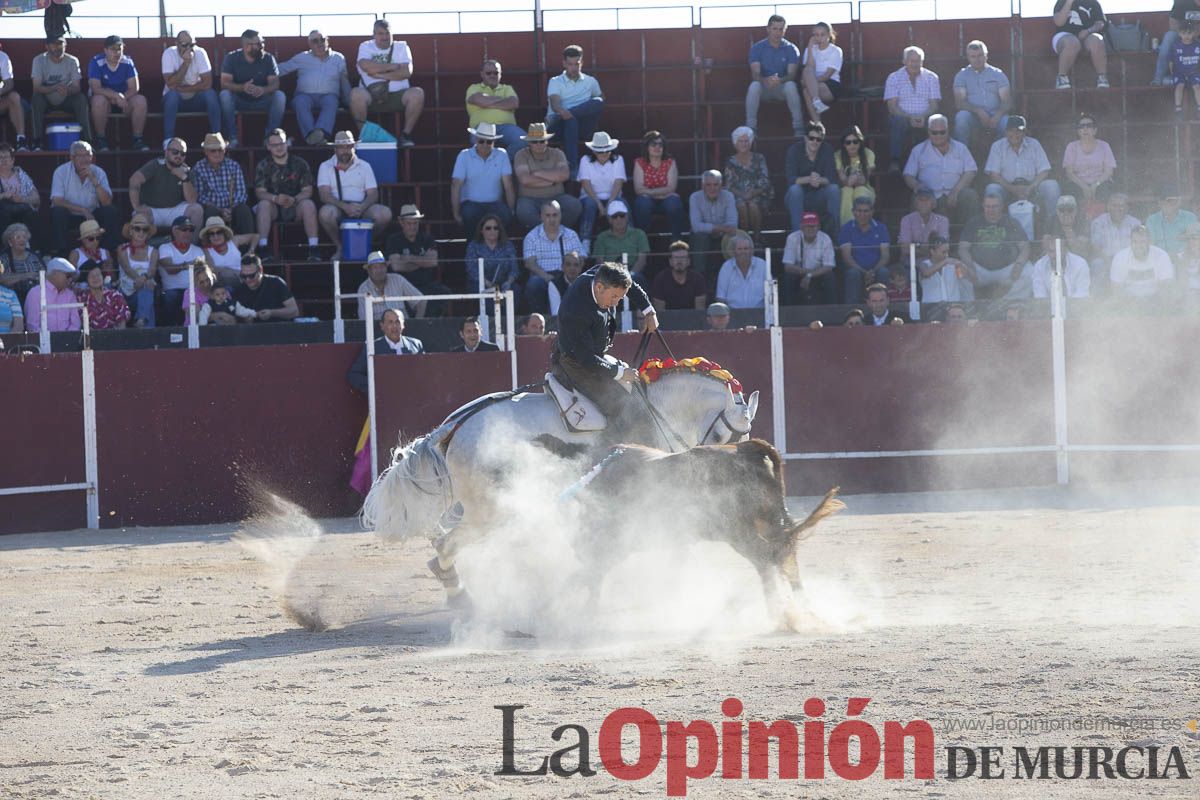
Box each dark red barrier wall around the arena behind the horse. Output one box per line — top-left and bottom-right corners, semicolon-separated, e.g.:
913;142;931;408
7;319;1200;533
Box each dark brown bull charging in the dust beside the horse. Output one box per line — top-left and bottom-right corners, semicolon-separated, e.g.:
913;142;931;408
570;439;846;628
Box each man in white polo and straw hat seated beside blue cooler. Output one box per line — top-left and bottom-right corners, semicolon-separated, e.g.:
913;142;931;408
317;131;391;260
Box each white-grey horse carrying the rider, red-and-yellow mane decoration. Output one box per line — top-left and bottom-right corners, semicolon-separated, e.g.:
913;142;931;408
361;367;758;597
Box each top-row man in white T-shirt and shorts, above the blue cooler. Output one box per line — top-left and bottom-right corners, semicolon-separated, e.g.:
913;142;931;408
350;19;425;148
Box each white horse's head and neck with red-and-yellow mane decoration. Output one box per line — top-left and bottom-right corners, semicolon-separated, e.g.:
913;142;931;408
641;357;758;446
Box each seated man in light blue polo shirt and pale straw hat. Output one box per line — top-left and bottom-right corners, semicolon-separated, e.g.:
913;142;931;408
450;122;516;239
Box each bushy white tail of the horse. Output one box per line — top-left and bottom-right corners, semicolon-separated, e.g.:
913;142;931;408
359;428;454;541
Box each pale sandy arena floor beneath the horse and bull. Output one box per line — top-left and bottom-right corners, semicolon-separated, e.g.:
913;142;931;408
0;487;1200;800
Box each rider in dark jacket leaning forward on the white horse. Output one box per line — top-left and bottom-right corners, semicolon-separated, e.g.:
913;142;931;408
550;261;659;444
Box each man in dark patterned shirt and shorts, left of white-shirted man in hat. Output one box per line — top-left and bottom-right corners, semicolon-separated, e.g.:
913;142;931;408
254;128;320;261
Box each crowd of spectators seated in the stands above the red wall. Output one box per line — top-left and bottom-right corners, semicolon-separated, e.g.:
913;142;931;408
0;7;1200;338
